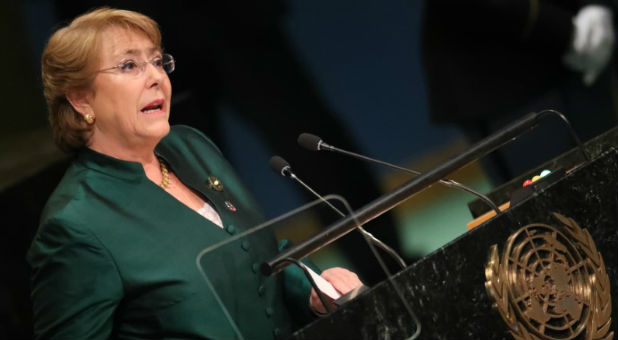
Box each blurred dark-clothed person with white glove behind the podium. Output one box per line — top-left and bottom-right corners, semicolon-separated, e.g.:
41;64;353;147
422;0;618;186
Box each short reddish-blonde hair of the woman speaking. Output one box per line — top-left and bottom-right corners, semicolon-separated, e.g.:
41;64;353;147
41;7;161;152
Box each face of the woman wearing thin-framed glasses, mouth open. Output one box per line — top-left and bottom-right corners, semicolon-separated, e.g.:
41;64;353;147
81;27;172;155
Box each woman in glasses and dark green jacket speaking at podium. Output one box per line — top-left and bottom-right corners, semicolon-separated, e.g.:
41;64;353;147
27;8;361;339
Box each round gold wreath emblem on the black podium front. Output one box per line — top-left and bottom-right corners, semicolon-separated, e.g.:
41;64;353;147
485;213;614;339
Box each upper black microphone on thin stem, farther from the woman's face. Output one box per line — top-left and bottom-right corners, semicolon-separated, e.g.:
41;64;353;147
297;132;501;215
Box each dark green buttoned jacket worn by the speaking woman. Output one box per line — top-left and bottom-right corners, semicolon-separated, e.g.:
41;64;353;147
27;126;310;339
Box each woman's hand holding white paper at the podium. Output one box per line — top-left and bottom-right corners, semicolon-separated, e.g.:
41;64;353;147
309;267;363;315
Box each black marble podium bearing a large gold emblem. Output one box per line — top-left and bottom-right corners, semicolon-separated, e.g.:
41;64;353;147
293;128;618;339
